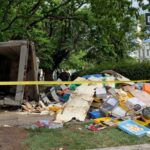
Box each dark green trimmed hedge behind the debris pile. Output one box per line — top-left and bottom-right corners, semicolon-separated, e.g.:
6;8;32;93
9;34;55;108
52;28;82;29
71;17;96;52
73;61;150;80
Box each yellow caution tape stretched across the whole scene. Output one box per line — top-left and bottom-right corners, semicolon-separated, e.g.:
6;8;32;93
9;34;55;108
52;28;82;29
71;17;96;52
0;80;150;85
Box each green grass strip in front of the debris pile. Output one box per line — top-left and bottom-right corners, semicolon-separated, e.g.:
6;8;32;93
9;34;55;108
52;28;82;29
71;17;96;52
25;124;150;150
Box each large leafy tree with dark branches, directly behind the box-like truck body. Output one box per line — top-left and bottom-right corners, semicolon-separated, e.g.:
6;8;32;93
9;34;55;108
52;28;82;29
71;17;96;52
0;0;89;79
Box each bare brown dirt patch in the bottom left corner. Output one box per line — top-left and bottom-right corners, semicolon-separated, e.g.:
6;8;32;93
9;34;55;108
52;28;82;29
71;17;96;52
0;127;27;150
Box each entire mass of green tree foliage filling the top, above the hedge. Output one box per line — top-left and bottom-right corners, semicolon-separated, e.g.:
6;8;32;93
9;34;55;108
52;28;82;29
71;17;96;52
0;0;148;73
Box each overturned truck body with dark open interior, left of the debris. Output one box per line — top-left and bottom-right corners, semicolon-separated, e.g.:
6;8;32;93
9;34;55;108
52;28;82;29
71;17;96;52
0;40;38;106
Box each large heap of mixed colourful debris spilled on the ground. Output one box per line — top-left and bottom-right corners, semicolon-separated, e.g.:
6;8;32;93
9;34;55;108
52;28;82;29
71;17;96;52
22;70;150;136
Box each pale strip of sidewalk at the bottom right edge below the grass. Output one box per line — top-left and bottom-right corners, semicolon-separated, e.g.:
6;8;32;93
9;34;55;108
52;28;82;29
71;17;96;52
91;144;150;150
